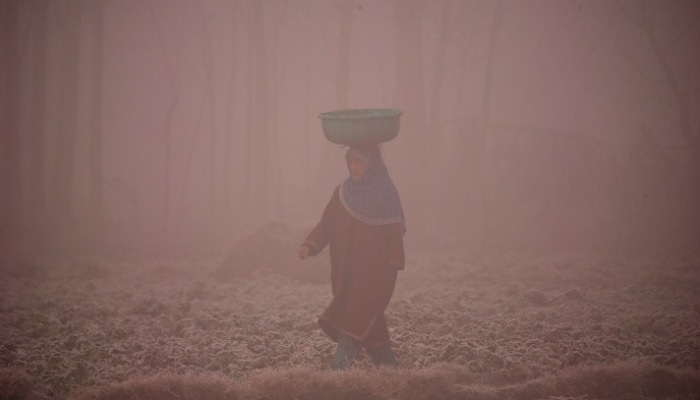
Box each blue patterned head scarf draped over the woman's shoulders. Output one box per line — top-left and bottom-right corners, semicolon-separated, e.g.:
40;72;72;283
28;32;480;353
340;146;406;230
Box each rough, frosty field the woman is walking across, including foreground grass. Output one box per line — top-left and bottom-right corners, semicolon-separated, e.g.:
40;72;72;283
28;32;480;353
0;231;700;399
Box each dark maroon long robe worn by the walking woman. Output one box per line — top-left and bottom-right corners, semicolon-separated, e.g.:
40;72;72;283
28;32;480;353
304;188;405;348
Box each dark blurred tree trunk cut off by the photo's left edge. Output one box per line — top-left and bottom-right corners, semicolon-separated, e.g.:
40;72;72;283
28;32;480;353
0;0;22;250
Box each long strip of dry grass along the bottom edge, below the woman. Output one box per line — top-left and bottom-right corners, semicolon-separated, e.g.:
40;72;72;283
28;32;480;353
61;362;700;400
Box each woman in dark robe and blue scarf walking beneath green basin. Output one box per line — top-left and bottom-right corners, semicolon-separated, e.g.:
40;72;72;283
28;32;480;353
298;145;406;369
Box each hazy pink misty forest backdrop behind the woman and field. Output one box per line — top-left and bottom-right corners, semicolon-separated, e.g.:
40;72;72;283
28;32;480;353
0;0;700;258
